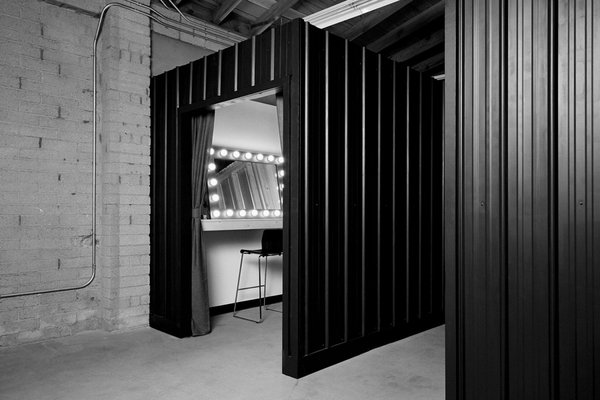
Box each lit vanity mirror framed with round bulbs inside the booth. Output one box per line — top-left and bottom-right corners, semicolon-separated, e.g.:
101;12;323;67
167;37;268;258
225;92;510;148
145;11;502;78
207;148;285;219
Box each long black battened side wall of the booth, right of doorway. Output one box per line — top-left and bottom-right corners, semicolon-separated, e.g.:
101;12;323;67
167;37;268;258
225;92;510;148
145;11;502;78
289;26;444;375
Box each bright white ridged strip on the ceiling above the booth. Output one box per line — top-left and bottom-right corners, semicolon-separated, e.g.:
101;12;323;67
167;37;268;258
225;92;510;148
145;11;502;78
304;0;398;29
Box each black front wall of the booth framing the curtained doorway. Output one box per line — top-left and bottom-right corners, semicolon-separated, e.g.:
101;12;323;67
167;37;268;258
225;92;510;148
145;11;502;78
150;25;298;337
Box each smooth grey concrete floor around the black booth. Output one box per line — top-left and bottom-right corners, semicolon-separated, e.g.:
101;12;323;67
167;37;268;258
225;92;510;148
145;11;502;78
0;312;444;400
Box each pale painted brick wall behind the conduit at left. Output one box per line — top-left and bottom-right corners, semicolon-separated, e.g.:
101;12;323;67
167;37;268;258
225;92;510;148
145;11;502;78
0;0;150;346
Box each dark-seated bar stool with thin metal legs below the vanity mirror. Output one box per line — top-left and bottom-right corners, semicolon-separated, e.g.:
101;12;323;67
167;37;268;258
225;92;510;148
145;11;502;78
233;229;283;324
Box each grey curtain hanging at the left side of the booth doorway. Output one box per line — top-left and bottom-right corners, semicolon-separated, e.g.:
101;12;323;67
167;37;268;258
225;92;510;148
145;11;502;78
191;111;215;336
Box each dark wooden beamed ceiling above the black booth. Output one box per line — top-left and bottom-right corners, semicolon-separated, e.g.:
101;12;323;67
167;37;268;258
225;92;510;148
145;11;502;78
166;0;445;75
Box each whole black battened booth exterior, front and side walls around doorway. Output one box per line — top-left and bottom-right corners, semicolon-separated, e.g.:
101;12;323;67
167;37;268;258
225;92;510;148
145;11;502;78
150;21;444;377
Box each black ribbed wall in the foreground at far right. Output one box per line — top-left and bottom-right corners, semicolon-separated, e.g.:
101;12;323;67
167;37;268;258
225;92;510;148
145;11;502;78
445;0;600;400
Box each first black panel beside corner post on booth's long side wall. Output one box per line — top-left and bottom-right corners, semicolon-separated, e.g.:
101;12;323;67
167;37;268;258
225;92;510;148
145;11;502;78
305;27;328;353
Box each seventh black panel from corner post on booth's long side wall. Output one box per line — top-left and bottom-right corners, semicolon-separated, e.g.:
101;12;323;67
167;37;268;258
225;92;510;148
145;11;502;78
405;69;421;323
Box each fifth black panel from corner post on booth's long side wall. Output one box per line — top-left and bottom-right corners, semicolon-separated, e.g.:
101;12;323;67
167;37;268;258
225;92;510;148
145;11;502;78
378;57;394;330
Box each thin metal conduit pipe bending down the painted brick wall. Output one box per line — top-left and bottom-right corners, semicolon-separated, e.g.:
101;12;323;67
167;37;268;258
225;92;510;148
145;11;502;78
0;0;227;300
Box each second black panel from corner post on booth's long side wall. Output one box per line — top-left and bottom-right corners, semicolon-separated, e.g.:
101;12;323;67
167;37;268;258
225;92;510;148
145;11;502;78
326;35;346;346
